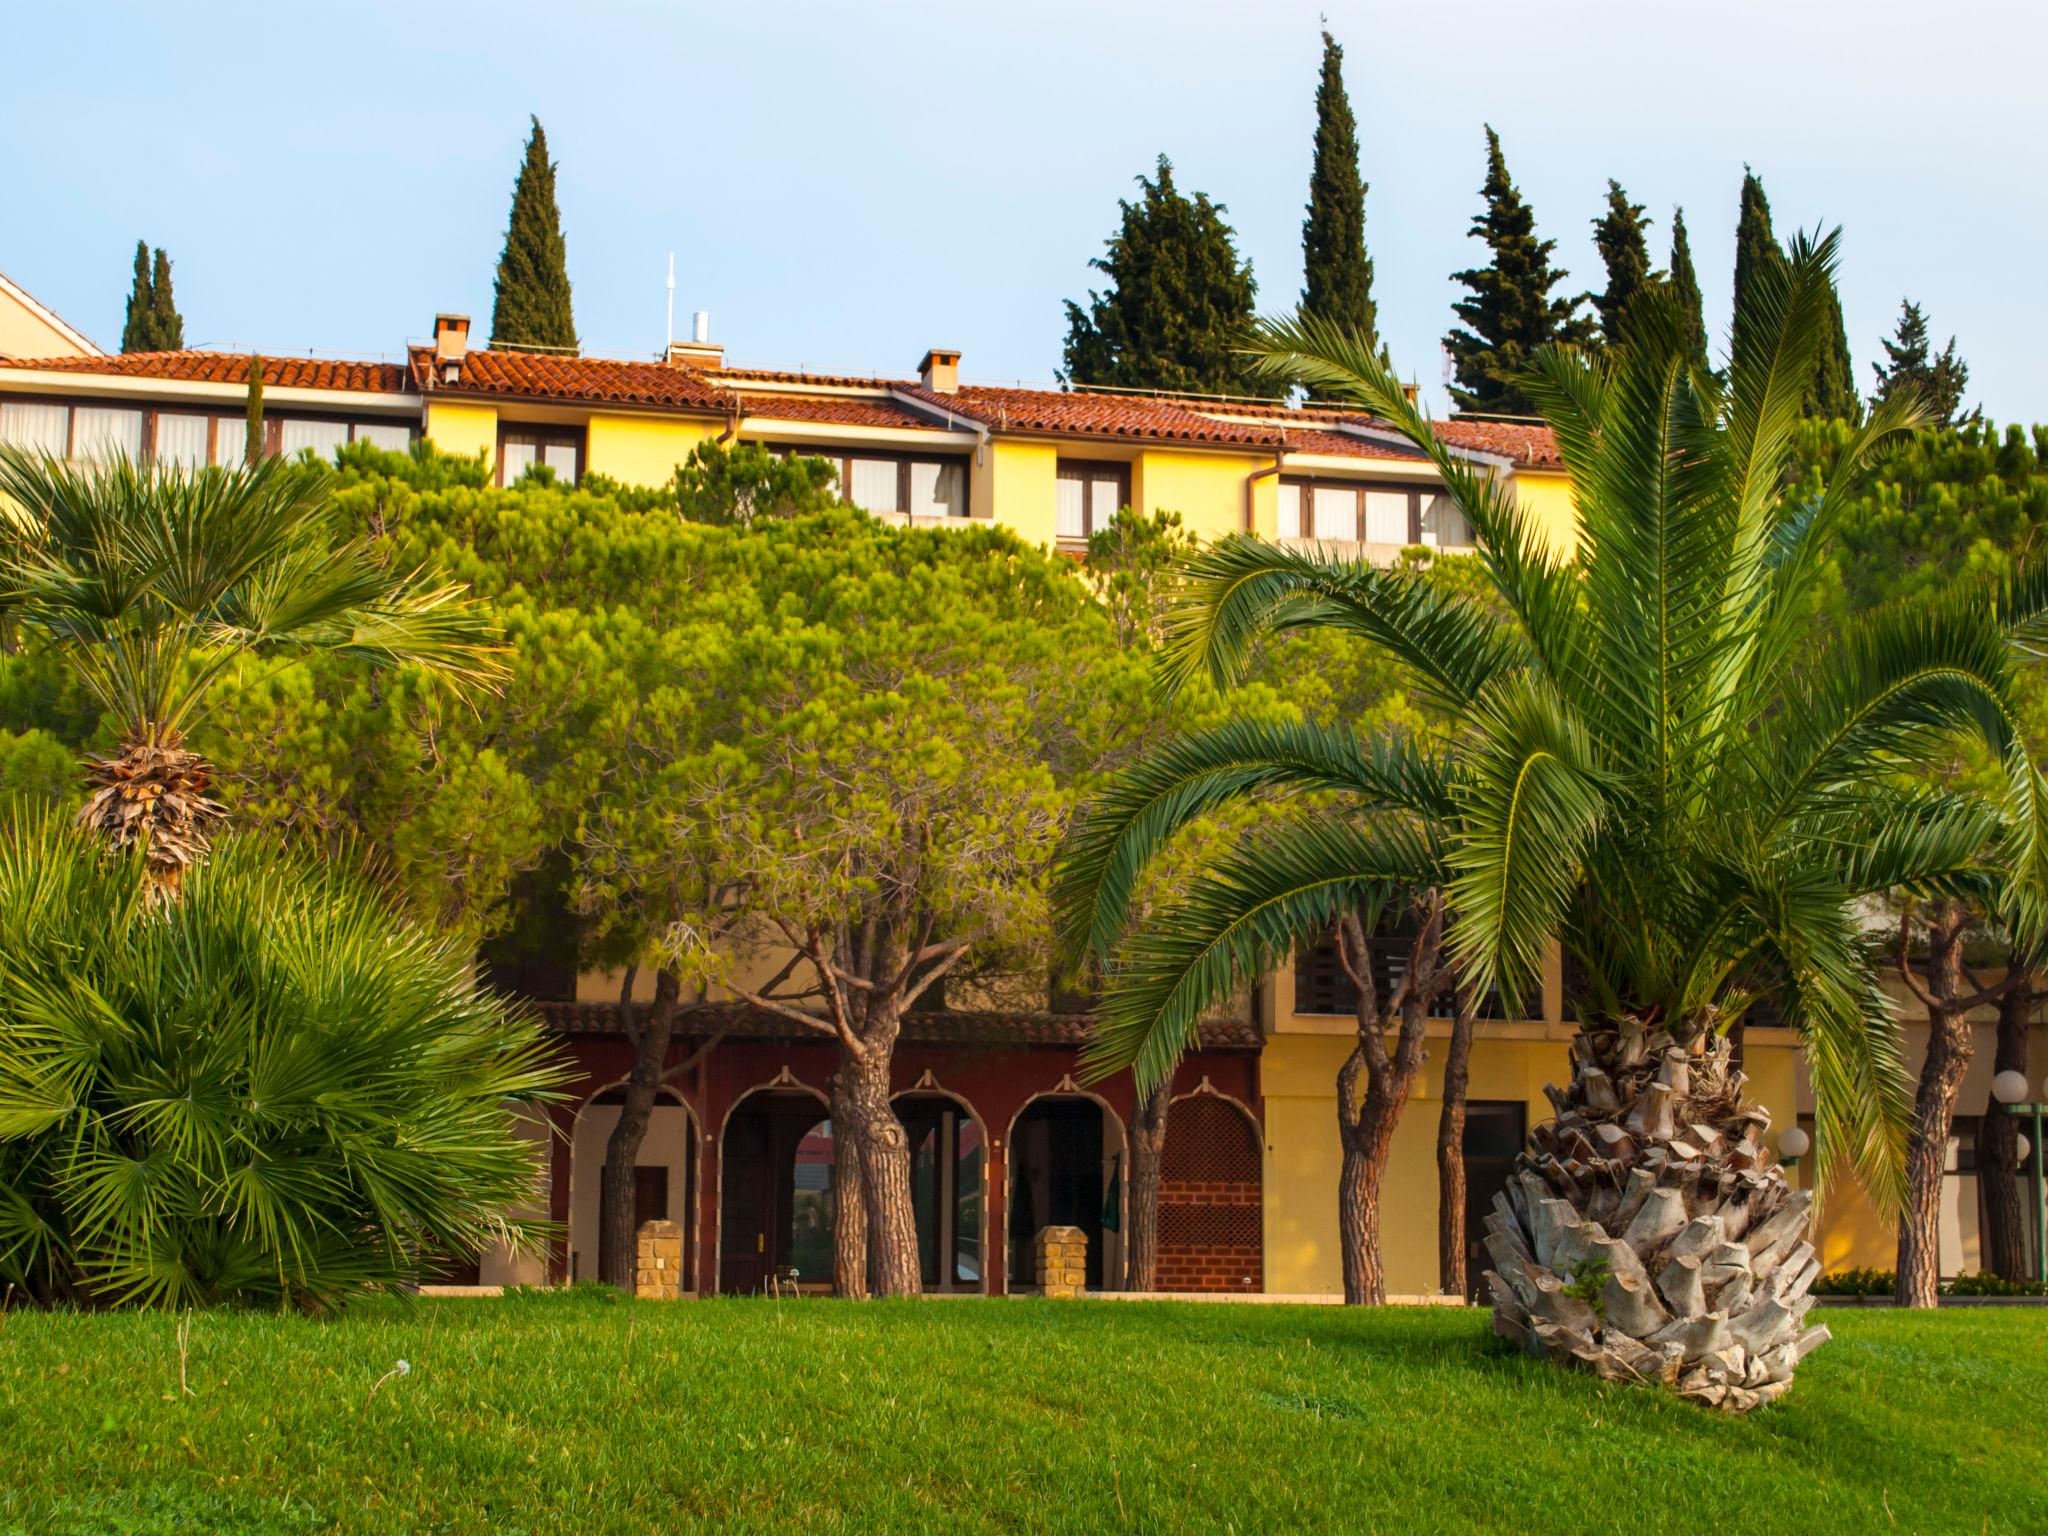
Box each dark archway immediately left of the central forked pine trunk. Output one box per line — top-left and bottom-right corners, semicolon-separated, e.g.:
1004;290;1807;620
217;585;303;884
719;1087;834;1296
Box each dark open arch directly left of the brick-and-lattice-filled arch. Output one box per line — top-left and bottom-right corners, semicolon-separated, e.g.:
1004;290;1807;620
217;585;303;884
1006;1094;1124;1290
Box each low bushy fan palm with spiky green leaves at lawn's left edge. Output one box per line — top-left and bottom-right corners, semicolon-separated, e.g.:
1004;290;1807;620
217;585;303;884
0;819;561;1307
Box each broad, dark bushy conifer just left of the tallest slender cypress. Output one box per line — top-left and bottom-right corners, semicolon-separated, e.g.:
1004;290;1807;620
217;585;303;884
1059;156;1274;395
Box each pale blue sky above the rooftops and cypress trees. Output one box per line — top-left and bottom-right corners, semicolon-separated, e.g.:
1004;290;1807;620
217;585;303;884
0;0;2048;422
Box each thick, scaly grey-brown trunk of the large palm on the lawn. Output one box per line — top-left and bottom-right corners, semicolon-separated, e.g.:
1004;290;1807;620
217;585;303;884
1487;1020;1829;1411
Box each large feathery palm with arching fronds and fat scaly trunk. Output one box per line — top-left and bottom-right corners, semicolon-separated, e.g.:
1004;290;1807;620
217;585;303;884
1063;236;2048;1409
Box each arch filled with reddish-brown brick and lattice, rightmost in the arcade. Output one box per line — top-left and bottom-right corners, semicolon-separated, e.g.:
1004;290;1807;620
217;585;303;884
1157;1092;1266;1290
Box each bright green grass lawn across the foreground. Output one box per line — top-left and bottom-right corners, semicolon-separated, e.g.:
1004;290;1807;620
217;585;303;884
0;1296;2048;1536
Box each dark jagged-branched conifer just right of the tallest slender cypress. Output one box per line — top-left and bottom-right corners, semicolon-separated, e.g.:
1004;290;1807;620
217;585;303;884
1444;125;1591;416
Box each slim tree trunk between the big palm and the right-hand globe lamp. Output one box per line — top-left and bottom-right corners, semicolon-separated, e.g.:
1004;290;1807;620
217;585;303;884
1894;905;1972;1307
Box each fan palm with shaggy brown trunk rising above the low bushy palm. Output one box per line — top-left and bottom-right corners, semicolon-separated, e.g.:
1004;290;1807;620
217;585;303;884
0;449;494;897
